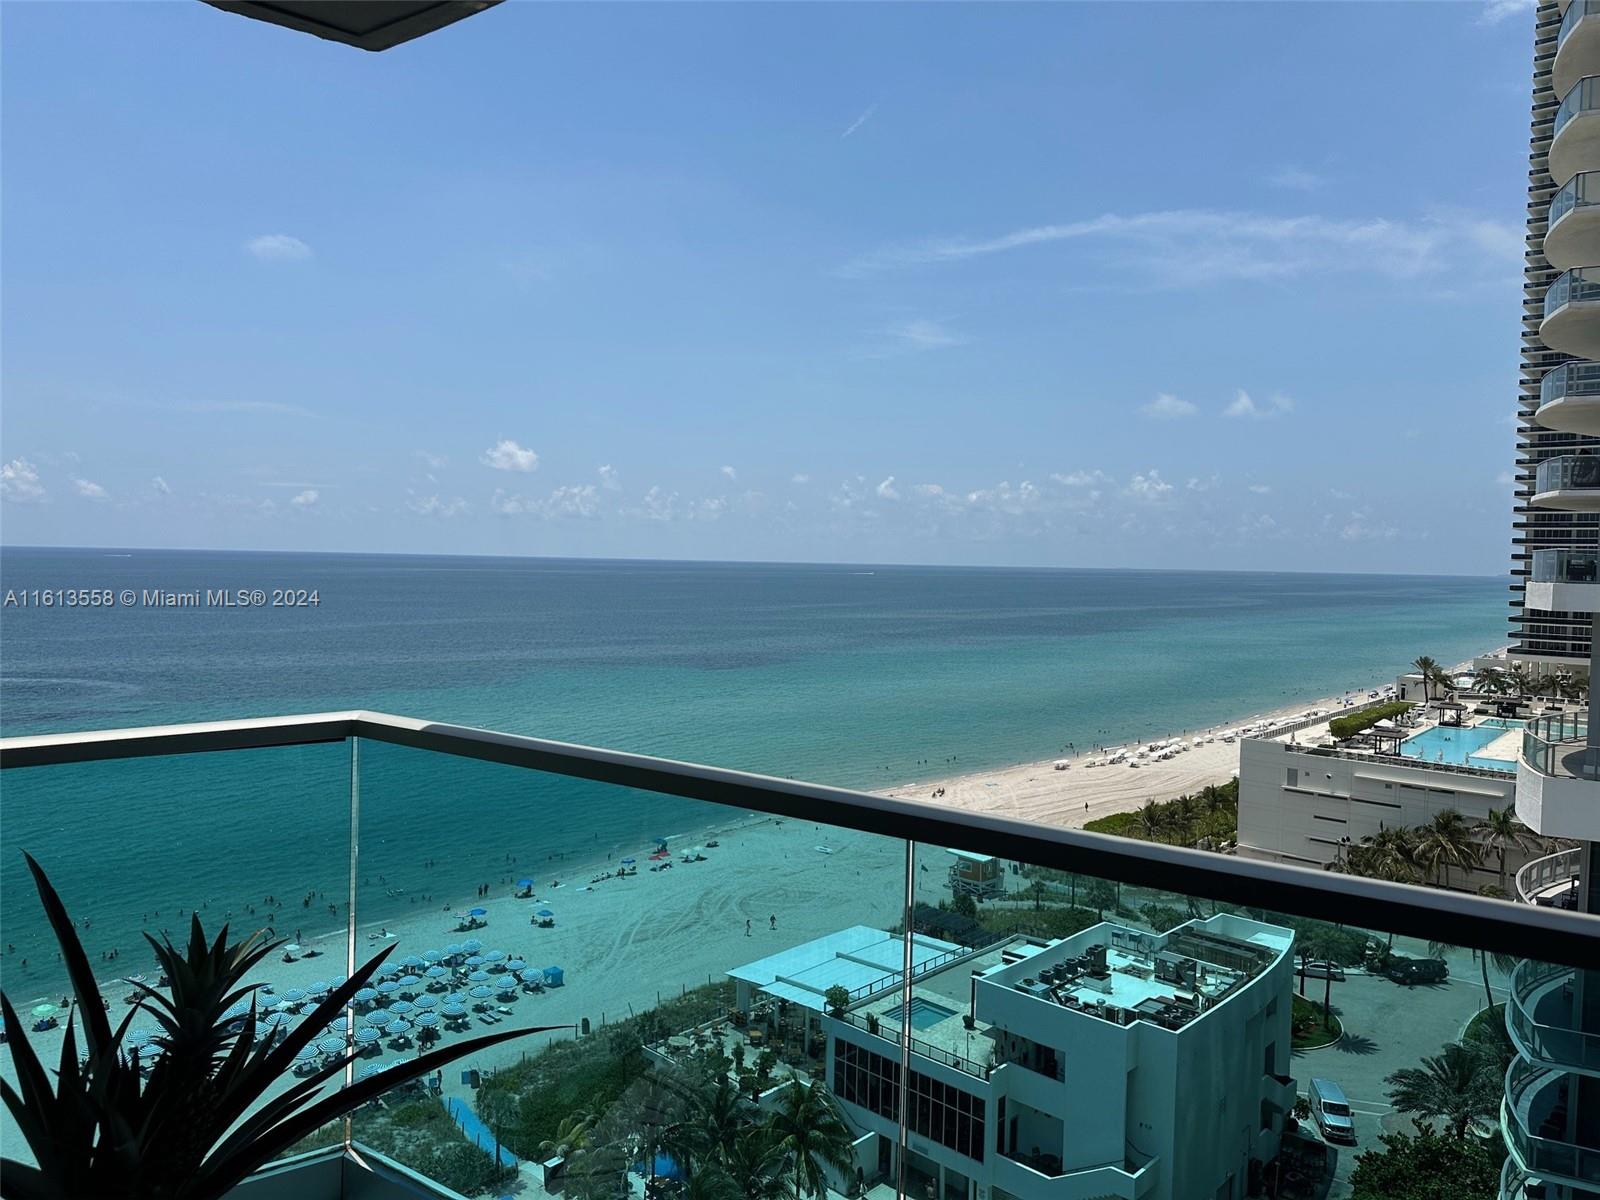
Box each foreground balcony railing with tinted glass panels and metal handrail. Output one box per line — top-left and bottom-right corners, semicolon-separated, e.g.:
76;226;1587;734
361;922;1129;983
0;714;1600;1200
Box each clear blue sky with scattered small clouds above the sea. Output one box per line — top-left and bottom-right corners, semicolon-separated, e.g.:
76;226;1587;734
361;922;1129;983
0;0;1531;574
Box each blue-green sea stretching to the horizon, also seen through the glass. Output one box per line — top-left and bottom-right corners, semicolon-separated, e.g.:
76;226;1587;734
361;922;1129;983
0;549;1506;998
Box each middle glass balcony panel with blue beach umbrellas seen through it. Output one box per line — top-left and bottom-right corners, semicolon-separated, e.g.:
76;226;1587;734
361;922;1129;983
352;739;906;1195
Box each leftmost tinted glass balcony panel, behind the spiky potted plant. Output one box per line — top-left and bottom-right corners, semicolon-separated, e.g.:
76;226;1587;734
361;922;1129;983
0;742;350;1157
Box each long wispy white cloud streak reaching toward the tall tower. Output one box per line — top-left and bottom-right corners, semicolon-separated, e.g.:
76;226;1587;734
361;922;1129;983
838;210;1522;286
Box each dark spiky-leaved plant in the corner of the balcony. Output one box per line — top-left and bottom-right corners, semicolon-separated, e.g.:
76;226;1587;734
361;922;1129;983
0;854;571;1200
